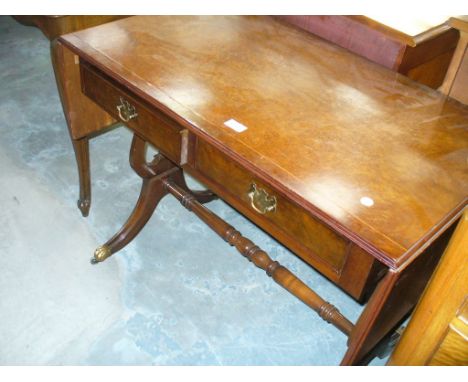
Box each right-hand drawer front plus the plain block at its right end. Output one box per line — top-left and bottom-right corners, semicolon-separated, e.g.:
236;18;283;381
191;140;386;302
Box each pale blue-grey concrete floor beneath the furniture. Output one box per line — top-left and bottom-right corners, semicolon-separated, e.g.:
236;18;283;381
0;17;384;365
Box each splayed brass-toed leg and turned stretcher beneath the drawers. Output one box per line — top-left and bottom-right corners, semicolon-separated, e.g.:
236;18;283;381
91;135;354;335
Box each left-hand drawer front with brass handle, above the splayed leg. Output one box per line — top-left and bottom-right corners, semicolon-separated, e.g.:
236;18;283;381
80;63;182;164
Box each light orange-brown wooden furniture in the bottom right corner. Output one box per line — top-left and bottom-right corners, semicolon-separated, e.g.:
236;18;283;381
388;210;468;365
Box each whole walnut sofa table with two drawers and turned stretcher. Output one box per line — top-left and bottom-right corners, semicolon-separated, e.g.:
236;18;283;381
54;16;468;365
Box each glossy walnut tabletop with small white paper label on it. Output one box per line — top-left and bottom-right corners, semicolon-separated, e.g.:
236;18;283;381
61;16;468;268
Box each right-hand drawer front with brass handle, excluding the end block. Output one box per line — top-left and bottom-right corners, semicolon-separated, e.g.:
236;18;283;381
195;140;350;281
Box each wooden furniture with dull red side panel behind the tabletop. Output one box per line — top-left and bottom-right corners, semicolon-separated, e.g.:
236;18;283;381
277;14;458;88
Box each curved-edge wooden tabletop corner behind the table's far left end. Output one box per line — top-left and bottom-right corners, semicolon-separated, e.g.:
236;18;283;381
13;15;128;40
